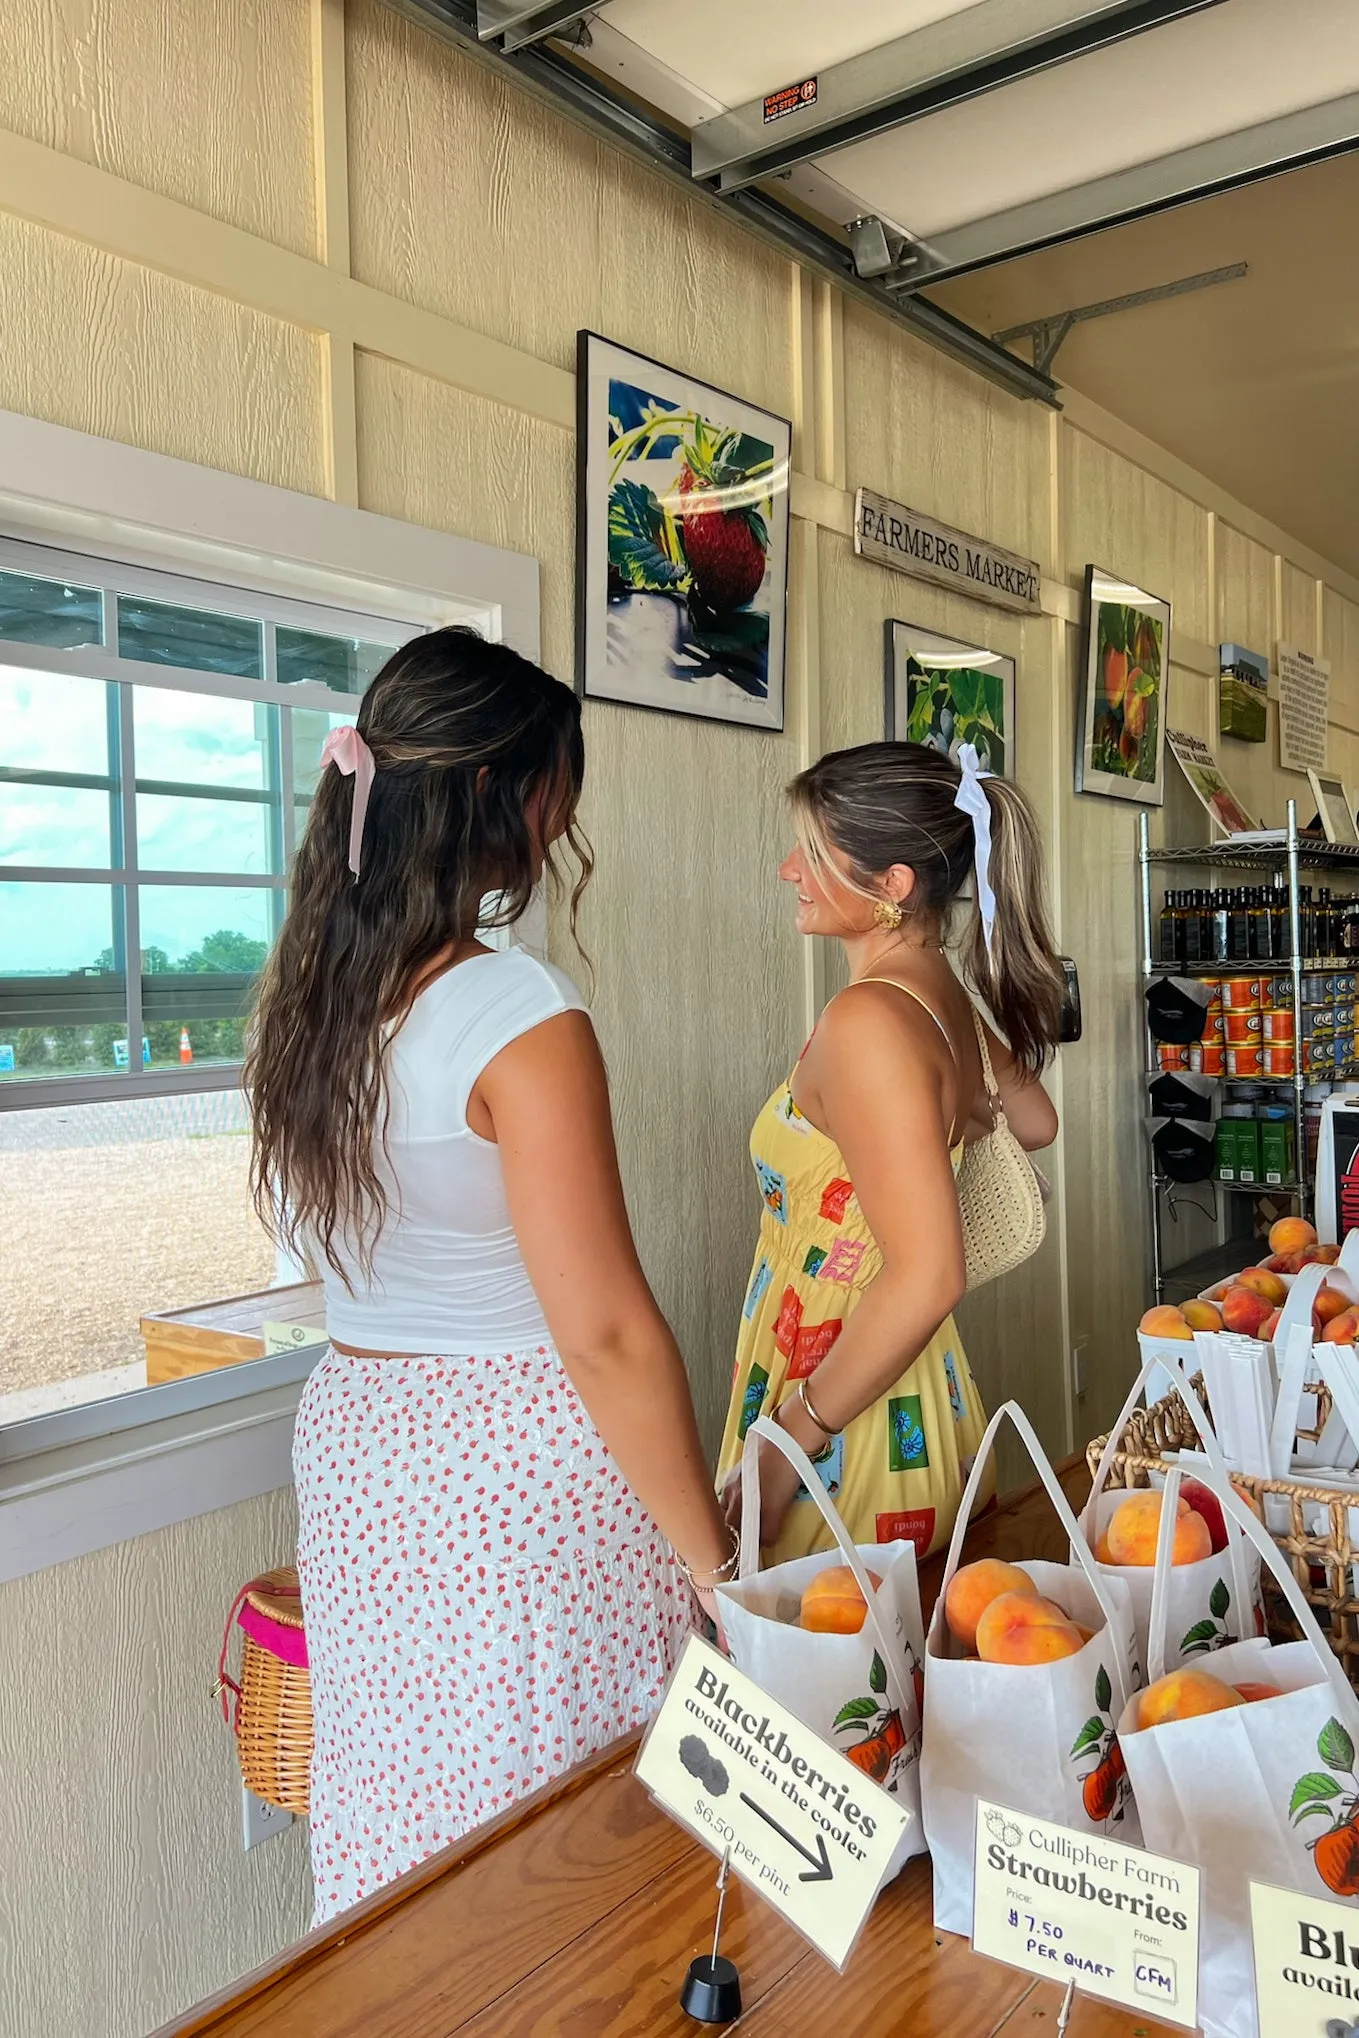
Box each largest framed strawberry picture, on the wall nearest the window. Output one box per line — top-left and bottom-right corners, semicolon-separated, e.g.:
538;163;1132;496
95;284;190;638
577;332;793;730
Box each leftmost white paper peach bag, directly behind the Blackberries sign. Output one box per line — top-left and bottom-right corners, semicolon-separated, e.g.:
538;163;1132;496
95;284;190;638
717;1416;925;1875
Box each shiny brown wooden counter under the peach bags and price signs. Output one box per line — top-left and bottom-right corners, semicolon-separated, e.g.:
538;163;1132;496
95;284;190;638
157;1459;1170;2038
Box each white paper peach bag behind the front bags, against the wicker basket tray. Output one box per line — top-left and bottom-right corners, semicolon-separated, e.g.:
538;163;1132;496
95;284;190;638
1072;1361;1265;1669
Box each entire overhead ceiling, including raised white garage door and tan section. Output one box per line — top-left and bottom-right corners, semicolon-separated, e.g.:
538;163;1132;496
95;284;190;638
456;0;1359;575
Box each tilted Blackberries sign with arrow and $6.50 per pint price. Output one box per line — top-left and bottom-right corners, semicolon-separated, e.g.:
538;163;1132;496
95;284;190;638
638;1634;915;1969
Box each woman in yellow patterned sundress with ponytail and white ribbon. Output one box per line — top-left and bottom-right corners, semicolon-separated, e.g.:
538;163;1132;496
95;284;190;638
719;742;1062;1563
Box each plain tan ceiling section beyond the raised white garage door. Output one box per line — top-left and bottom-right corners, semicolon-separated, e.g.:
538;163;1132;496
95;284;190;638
937;155;1359;575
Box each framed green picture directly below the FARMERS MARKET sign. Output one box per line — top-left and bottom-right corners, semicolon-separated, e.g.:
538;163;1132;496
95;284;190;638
884;618;1015;779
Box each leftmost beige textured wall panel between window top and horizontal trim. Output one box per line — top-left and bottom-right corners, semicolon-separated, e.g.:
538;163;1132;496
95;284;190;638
0;212;324;495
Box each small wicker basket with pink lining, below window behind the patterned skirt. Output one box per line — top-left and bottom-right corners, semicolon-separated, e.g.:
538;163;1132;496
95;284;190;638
218;1565;312;1816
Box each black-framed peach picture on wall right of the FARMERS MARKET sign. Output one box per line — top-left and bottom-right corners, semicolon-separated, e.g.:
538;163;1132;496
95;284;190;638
1076;567;1170;807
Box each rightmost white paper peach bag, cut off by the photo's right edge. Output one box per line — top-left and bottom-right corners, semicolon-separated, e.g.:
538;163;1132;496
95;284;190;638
1119;1471;1359;2038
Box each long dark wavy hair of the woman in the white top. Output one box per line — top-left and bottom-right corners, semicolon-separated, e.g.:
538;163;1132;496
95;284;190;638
244;628;591;1280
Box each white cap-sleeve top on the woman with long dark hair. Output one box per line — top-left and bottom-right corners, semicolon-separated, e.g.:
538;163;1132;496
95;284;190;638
318;948;585;1357
